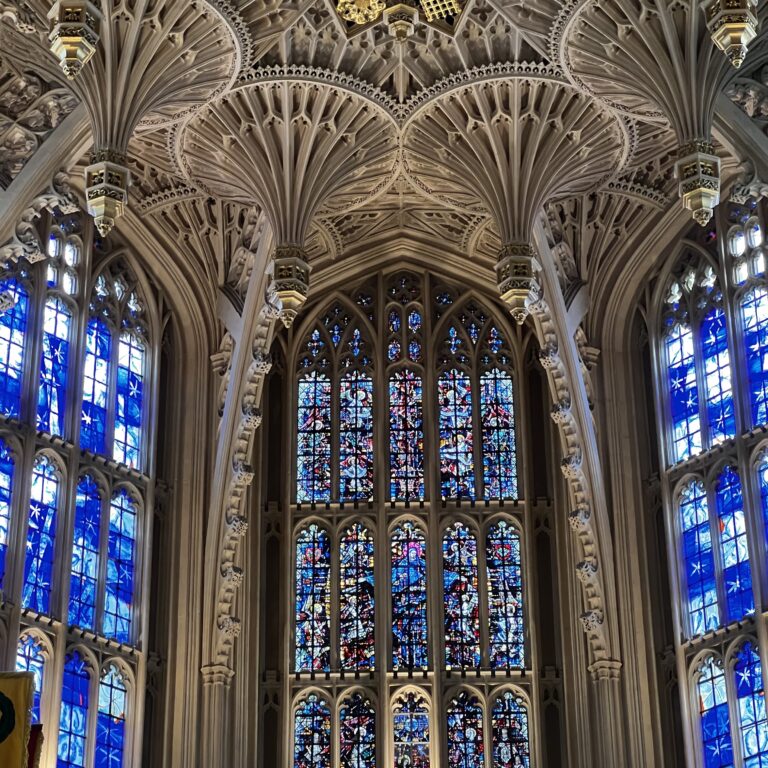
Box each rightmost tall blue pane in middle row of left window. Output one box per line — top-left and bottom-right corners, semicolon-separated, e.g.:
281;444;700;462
104;488;137;643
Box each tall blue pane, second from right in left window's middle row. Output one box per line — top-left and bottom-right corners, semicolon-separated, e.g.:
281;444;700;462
69;475;101;630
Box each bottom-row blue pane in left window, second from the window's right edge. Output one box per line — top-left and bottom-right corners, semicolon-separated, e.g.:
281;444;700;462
56;651;91;768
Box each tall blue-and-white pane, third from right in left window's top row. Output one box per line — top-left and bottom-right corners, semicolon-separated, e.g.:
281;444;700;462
37;296;72;436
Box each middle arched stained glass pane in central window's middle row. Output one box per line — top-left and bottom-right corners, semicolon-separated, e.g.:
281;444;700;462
392;521;428;669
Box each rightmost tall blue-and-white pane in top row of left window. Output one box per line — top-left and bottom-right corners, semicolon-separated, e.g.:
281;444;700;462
113;333;145;468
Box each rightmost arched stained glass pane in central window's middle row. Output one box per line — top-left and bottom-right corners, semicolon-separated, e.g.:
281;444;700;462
485;520;525;669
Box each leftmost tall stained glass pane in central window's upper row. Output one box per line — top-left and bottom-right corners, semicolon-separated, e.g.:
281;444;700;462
296;371;331;503
